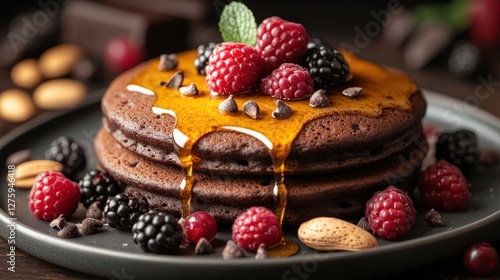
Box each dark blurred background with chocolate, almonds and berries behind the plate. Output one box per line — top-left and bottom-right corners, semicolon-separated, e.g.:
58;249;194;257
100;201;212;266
0;0;500;136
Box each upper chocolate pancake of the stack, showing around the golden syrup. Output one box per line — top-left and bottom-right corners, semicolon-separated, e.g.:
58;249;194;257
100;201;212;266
102;49;426;174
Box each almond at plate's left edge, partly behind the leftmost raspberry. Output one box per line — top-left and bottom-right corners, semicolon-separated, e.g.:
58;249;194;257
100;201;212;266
11;159;63;189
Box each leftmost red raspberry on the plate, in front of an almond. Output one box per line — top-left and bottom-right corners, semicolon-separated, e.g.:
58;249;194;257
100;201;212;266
28;171;80;221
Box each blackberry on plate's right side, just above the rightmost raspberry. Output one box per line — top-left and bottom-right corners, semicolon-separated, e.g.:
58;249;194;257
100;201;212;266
436;129;479;171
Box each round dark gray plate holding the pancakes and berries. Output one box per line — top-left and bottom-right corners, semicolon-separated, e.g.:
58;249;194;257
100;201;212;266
0;91;500;279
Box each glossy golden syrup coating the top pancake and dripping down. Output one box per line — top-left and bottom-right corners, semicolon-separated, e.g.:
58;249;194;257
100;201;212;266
129;50;418;256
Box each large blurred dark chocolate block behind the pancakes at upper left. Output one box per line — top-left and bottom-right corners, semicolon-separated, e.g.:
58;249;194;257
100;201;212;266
61;0;189;59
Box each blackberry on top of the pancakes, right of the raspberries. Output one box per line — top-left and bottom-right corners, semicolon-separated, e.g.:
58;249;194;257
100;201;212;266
304;39;349;90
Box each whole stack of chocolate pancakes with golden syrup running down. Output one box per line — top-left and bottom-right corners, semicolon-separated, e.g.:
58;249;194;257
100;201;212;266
95;50;427;225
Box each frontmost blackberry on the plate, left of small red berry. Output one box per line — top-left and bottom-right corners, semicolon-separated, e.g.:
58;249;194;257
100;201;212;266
132;211;183;253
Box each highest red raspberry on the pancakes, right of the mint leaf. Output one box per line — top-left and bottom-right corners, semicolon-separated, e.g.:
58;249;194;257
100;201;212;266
255;17;309;73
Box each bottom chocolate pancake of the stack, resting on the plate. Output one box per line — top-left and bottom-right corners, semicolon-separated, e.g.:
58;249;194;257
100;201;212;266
95;129;425;225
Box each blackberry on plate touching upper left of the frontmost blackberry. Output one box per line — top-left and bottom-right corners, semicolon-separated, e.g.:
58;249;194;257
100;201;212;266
102;193;149;230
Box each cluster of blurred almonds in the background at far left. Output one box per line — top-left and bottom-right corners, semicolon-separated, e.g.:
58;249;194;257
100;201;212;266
0;44;92;124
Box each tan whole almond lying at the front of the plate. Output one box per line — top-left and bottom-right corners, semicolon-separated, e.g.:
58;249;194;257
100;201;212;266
298;217;378;251
